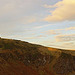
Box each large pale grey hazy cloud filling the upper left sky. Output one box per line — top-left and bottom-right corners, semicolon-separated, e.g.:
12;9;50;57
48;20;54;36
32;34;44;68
0;0;40;35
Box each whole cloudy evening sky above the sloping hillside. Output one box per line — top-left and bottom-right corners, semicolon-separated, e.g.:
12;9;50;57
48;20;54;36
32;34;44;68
0;0;75;50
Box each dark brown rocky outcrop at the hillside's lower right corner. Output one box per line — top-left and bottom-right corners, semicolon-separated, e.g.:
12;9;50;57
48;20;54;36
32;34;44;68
53;52;75;74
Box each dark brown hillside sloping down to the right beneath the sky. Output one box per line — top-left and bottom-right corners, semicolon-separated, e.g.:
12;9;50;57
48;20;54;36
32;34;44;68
0;38;75;75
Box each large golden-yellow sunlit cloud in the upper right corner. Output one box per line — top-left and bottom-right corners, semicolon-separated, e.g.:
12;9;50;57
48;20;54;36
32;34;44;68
44;0;75;22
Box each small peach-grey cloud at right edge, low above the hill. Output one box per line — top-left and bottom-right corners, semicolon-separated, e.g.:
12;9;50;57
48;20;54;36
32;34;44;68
55;34;75;42
